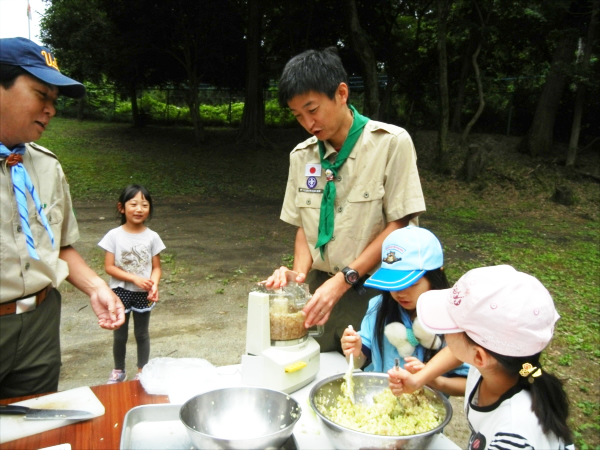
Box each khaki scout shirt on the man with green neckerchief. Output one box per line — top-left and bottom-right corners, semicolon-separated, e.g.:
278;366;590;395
281;120;425;273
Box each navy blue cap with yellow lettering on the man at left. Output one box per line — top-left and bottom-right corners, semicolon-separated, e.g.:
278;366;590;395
0;37;85;98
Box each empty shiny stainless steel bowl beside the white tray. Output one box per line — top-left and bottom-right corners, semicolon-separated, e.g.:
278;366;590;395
179;386;302;449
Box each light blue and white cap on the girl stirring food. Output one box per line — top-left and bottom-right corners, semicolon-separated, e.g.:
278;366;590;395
365;225;444;291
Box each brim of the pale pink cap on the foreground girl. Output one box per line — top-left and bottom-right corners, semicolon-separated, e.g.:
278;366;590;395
417;289;463;334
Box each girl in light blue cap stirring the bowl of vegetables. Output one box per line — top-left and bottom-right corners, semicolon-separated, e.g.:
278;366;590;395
341;226;469;395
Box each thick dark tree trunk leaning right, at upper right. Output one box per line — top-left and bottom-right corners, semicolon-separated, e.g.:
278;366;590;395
519;30;577;156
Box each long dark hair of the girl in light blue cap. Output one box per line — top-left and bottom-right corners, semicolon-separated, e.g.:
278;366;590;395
373;267;450;362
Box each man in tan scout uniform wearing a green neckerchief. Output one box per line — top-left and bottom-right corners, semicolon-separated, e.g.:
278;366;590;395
267;49;425;352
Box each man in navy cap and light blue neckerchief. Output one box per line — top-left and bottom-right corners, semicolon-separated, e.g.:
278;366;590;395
0;38;125;398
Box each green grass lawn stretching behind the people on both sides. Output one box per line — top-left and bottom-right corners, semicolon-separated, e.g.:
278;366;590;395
39;119;600;448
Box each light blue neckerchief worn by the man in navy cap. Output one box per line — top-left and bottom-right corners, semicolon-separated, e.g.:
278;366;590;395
0;143;55;260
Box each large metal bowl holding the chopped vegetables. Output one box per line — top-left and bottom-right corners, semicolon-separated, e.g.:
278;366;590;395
310;372;452;449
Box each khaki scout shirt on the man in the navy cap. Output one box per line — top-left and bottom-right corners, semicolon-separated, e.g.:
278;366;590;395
0;144;79;303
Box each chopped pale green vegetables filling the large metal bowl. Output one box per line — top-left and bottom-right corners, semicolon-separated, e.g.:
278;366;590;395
315;388;446;436
